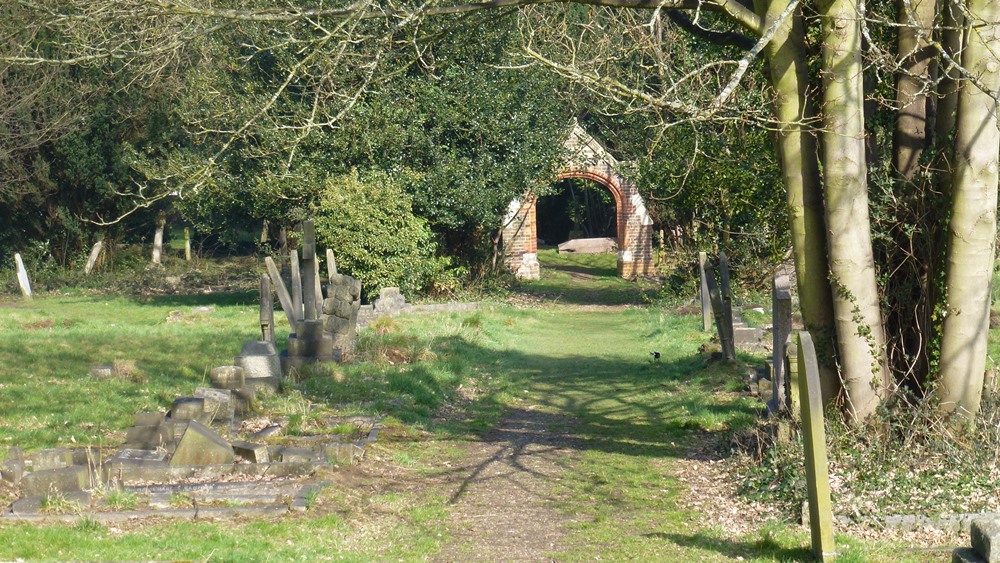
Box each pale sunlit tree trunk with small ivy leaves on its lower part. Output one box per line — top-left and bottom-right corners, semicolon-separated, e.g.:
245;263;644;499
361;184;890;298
821;0;887;421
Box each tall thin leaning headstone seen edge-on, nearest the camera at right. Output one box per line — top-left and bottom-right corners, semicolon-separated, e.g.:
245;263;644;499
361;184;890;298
798;331;836;561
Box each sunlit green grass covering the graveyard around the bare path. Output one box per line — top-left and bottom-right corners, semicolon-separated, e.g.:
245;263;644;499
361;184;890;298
0;266;956;561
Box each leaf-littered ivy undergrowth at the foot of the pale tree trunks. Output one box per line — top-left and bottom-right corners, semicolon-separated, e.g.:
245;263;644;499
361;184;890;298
731;384;1000;524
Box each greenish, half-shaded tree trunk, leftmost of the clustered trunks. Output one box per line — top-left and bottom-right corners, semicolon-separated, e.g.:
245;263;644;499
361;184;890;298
755;0;840;404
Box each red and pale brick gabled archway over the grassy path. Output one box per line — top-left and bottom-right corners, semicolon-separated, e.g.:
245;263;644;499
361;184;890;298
503;123;654;279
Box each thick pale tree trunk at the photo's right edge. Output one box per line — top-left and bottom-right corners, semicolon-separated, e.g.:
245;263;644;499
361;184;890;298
938;0;1000;421
